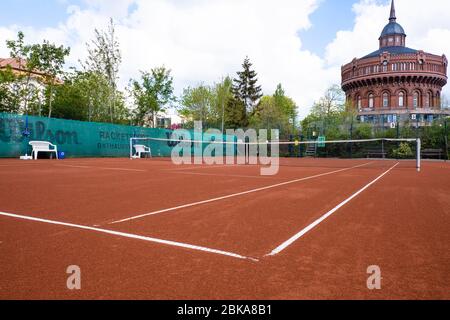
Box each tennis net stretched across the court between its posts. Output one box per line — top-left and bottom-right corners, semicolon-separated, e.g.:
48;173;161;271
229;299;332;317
130;137;421;169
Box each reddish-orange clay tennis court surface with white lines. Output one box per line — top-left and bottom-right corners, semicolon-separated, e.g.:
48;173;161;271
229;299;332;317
0;159;450;299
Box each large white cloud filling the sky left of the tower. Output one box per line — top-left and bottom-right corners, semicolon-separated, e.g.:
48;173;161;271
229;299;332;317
0;0;336;119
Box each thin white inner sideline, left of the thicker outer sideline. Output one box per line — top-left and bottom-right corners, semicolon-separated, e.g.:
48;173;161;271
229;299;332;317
109;162;372;224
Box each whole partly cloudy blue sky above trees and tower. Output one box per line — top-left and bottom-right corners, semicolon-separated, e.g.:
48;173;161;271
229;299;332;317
0;0;450;118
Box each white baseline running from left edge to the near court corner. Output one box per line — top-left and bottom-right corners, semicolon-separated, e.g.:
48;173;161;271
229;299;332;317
0;212;258;261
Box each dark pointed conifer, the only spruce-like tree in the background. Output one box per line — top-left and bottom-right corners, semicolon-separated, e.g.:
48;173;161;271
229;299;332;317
232;57;262;113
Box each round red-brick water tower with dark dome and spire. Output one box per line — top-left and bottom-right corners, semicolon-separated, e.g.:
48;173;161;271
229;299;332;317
342;0;450;126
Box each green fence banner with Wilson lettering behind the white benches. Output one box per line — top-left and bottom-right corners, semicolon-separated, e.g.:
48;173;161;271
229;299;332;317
0;113;173;158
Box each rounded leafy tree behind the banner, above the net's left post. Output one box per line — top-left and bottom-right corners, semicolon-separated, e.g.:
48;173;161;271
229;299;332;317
129;67;175;127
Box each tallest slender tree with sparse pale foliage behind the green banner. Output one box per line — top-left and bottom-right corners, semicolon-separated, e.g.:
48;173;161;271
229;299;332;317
81;19;122;122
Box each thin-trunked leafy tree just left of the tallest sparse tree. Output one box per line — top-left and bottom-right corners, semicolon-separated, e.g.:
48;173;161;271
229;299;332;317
37;41;70;118
